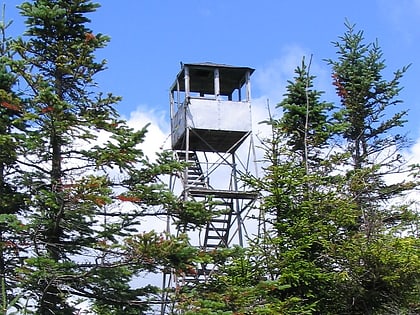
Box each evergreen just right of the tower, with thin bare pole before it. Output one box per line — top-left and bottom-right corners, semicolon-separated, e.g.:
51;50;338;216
240;61;342;314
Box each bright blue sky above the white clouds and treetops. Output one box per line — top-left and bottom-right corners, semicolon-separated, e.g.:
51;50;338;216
6;0;420;144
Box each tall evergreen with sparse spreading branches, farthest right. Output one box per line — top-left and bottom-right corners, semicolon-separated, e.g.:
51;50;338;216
328;23;419;314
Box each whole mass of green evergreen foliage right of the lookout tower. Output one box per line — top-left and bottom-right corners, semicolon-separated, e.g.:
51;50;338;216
176;23;420;314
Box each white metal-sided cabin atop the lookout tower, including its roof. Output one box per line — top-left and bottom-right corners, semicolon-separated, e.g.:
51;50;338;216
170;63;254;152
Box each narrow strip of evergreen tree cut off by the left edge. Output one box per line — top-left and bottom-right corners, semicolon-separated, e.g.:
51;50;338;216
0;6;27;310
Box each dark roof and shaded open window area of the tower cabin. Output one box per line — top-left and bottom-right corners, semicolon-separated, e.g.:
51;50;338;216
171;62;255;95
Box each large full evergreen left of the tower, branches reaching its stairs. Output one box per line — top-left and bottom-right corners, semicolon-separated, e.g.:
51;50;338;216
6;0;204;315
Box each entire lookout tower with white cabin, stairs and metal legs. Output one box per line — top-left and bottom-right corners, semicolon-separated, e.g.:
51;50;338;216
162;63;256;308
